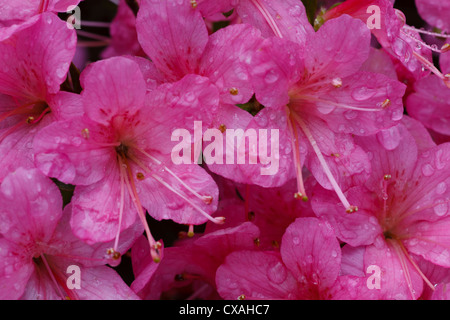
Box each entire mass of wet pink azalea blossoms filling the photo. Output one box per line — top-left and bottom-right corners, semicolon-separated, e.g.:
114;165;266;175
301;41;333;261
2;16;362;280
0;0;450;300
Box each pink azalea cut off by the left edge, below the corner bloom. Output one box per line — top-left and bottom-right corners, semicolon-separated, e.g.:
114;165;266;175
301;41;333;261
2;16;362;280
0;13;76;181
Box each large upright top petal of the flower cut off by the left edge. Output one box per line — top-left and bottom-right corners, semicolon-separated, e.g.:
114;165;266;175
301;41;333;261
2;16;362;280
0;13;76;102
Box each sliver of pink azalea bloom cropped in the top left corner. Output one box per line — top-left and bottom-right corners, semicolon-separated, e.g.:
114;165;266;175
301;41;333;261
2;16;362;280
0;0;82;24
